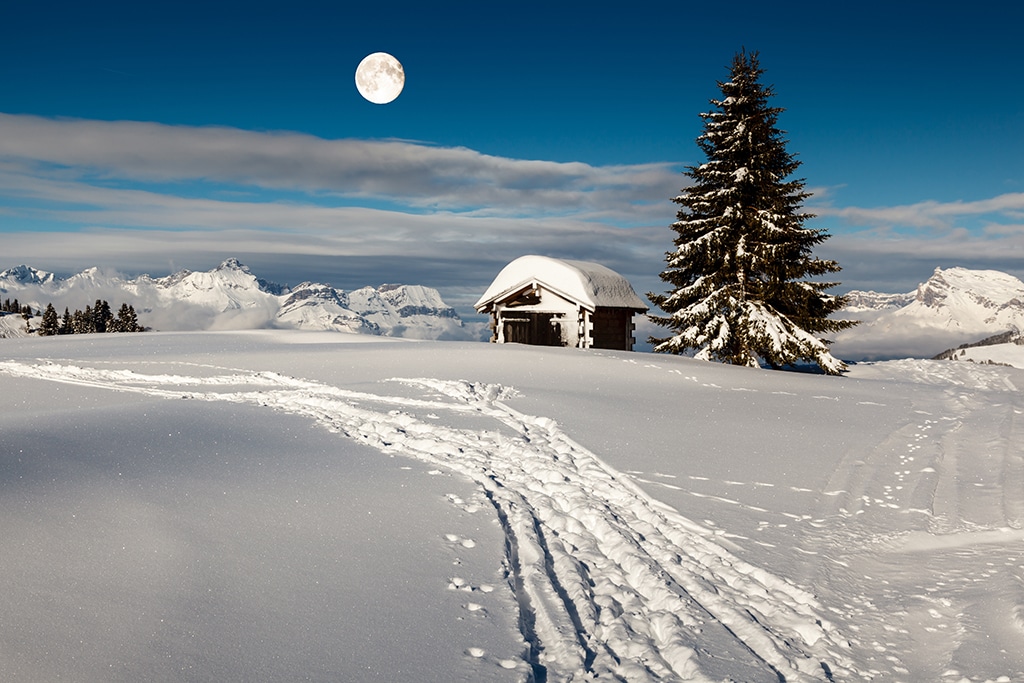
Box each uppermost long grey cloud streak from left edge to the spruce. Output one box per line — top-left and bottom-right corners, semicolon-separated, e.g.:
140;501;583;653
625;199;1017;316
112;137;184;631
0;114;682;221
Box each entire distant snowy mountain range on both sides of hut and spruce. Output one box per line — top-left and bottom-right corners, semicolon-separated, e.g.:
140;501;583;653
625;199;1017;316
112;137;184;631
9;258;1024;360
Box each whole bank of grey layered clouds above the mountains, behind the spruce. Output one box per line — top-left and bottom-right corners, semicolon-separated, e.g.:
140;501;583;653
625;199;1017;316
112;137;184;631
0;114;1024;313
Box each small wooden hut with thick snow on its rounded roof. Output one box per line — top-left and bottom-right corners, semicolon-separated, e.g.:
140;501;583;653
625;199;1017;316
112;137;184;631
475;256;647;351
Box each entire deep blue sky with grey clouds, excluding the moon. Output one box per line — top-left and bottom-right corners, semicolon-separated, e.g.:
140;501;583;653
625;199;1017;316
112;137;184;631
0;0;1024;311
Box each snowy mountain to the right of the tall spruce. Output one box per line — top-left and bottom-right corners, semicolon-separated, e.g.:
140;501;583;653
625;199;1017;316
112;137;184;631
833;268;1024;359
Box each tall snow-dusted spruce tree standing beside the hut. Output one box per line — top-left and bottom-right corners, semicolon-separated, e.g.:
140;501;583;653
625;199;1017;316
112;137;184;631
647;50;855;374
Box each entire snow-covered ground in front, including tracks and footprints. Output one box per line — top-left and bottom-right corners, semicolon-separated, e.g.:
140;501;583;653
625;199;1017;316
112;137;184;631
0;331;1024;682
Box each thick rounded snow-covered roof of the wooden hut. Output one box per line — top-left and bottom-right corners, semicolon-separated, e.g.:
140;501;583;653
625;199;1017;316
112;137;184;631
475;255;647;310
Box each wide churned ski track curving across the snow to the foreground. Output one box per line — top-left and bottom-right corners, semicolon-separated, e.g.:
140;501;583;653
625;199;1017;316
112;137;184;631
0;361;860;683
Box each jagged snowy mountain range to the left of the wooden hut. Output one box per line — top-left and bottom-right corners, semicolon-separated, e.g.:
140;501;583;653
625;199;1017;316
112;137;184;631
0;258;471;340
